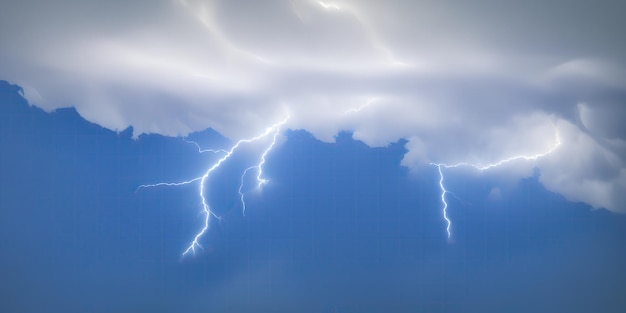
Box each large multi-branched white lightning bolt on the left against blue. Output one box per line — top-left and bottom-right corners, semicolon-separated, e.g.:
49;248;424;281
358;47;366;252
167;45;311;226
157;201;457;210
137;116;289;256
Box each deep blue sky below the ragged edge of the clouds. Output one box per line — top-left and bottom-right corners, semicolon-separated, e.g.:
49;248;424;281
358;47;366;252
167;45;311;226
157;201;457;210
0;83;626;312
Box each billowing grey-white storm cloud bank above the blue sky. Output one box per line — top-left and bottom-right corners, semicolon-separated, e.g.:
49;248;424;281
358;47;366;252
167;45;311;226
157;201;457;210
0;0;626;212
